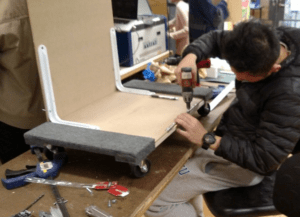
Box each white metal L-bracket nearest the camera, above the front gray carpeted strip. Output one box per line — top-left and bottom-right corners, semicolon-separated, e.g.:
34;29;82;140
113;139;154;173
38;45;100;130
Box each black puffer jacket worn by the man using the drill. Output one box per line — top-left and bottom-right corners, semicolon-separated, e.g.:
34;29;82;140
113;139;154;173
184;27;300;175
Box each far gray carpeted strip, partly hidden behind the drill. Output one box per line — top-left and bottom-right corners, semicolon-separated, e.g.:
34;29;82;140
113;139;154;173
123;79;213;100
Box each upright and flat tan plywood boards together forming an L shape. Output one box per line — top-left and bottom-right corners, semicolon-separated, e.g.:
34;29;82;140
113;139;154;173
28;0;203;145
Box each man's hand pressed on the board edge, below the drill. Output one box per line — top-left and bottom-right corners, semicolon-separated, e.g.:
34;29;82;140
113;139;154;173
175;113;207;147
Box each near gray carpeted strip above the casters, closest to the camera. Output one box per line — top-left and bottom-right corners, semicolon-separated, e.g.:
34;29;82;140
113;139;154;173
24;122;155;165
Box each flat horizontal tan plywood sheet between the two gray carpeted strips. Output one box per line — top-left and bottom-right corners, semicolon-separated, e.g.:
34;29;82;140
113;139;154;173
63;92;203;145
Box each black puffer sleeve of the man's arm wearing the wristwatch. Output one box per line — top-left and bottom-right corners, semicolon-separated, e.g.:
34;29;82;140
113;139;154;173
215;81;300;175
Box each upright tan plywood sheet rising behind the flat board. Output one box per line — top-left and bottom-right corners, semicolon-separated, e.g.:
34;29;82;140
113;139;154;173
27;0;115;116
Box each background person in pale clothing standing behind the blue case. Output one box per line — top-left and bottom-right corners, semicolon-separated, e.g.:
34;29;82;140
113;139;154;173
167;0;189;56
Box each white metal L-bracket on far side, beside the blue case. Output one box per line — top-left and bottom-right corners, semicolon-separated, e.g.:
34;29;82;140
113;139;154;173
110;28;155;96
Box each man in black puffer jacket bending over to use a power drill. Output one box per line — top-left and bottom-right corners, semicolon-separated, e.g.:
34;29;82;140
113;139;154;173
147;21;300;217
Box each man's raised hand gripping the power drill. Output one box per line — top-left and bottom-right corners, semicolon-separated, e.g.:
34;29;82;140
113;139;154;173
175;53;197;88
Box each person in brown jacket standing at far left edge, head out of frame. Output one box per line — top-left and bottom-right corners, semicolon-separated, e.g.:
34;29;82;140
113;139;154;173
0;0;46;163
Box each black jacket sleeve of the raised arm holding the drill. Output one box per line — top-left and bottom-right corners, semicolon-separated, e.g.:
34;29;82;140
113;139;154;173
182;30;228;62
